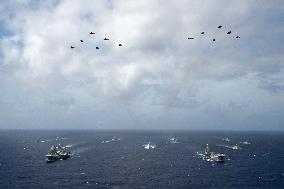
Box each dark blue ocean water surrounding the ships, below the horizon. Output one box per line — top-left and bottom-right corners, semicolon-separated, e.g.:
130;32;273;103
0;130;284;189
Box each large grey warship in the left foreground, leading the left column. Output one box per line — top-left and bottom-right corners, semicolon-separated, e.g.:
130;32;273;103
45;145;71;162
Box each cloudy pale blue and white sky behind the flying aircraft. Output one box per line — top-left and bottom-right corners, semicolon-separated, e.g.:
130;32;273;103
0;0;284;130
